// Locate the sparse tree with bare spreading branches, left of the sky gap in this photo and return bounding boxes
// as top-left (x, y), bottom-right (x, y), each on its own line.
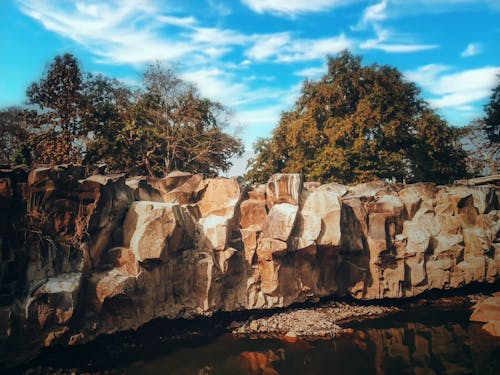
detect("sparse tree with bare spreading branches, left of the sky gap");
top-left (86, 64), bottom-right (243, 176)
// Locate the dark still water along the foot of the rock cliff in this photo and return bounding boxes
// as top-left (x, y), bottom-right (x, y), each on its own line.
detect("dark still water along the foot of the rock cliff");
top-left (11, 310), bottom-right (500, 375)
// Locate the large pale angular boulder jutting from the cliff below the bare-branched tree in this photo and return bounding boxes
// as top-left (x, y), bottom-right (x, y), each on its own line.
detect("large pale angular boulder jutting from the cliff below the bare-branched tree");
top-left (123, 202), bottom-right (189, 262)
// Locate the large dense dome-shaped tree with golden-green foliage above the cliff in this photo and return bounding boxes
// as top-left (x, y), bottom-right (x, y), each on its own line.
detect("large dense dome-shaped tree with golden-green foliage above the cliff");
top-left (246, 51), bottom-right (464, 183)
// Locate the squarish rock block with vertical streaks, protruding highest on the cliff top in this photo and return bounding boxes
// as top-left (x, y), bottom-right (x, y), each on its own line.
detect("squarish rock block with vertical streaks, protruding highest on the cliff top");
top-left (266, 173), bottom-right (302, 207)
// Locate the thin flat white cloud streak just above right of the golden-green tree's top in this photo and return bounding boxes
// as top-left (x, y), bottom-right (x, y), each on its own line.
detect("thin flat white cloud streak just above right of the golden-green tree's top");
top-left (360, 26), bottom-right (439, 53)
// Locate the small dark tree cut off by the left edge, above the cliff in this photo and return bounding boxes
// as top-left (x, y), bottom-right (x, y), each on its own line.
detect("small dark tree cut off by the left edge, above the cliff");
top-left (0, 107), bottom-right (29, 163)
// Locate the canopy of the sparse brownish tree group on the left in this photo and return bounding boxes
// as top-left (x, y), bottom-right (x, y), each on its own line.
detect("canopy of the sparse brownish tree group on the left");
top-left (0, 54), bottom-right (243, 176)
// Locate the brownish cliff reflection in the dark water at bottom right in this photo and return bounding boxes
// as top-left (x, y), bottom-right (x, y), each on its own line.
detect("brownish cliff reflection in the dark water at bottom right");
top-left (354, 323), bottom-right (500, 375)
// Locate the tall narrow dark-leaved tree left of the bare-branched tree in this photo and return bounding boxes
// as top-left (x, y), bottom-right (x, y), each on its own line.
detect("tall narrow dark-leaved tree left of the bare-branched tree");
top-left (26, 54), bottom-right (84, 165)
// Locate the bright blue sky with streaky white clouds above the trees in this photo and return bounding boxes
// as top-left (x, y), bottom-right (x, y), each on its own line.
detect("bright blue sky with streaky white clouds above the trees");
top-left (0, 0), bottom-right (500, 175)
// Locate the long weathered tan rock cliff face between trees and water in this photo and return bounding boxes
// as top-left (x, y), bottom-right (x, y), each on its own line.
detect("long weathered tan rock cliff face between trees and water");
top-left (0, 166), bottom-right (500, 358)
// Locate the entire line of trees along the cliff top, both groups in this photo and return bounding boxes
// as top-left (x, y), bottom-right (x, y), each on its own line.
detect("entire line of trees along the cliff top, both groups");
top-left (0, 51), bottom-right (500, 183)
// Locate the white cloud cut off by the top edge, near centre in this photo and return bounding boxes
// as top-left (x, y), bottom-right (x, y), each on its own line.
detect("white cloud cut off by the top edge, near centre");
top-left (243, 0), bottom-right (355, 15)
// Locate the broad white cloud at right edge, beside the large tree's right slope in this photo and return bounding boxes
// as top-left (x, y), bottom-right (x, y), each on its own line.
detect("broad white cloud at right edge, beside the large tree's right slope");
top-left (405, 64), bottom-right (500, 111)
